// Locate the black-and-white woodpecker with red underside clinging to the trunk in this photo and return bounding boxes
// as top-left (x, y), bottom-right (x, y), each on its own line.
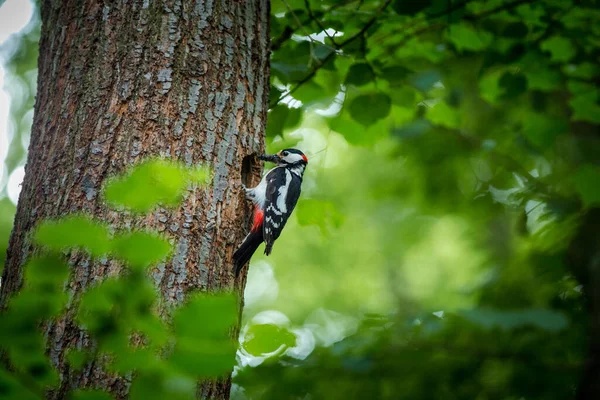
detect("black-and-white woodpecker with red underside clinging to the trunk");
top-left (233, 149), bottom-right (308, 275)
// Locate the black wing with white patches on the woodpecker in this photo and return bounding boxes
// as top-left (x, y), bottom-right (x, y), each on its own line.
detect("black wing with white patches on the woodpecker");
top-left (263, 168), bottom-right (302, 255)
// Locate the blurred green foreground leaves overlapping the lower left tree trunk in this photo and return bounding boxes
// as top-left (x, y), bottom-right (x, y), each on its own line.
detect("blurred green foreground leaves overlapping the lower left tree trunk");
top-left (0, 161), bottom-right (238, 399)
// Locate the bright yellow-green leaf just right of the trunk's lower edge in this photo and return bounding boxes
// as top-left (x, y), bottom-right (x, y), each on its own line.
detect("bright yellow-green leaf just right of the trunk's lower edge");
top-left (242, 324), bottom-right (296, 357)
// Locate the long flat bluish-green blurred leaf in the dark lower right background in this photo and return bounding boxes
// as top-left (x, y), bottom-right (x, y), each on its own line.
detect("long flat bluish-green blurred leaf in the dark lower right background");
top-left (460, 308), bottom-right (569, 332)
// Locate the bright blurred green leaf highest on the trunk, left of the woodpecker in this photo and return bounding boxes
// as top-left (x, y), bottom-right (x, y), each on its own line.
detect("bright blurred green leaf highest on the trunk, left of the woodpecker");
top-left (104, 160), bottom-right (188, 212)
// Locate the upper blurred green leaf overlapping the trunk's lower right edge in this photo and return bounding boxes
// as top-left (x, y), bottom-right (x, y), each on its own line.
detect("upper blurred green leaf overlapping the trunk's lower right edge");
top-left (173, 294), bottom-right (237, 339)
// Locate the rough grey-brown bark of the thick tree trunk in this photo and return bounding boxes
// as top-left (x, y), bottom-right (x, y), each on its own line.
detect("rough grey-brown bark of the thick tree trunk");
top-left (0, 0), bottom-right (269, 398)
